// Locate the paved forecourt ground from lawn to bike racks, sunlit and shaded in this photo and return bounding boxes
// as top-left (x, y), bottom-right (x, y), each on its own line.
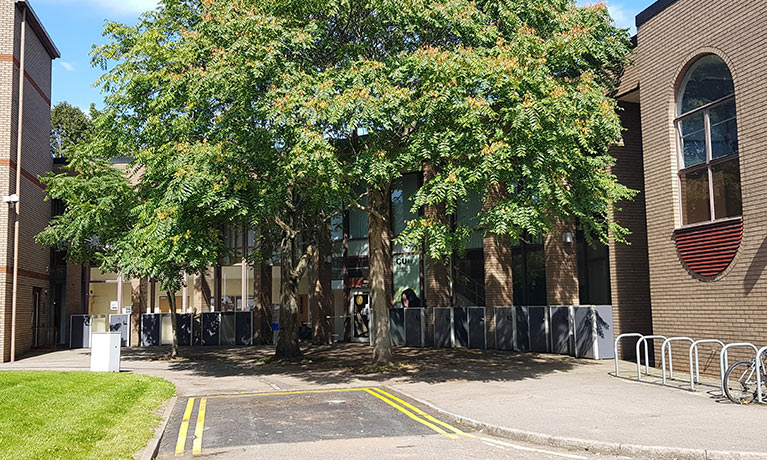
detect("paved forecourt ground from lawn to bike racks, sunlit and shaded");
top-left (0, 344), bottom-right (767, 459)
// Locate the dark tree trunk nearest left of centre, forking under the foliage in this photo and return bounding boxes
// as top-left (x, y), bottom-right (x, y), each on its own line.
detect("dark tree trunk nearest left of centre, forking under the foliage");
top-left (274, 236), bottom-right (301, 358)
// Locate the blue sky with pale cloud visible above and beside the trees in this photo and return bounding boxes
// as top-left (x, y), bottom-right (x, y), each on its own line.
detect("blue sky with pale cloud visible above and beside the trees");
top-left (30, 0), bottom-right (654, 110)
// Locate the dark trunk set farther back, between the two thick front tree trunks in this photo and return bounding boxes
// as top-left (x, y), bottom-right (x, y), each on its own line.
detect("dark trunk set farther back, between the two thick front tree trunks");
top-left (312, 221), bottom-right (333, 345)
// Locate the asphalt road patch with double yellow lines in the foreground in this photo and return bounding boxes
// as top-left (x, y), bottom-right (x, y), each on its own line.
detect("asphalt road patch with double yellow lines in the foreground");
top-left (158, 388), bottom-right (628, 460)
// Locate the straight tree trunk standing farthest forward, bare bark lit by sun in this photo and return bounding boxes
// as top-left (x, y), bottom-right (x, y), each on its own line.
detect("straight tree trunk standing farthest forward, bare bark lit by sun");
top-left (368, 187), bottom-right (393, 365)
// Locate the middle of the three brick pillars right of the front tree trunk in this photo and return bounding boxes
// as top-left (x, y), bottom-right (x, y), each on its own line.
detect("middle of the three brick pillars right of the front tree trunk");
top-left (483, 187), bottom-right (514, 348)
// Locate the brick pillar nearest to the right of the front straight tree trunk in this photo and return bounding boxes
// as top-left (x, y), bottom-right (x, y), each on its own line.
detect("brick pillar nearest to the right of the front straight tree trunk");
top-left (424, 162), bottom-right (452, 343)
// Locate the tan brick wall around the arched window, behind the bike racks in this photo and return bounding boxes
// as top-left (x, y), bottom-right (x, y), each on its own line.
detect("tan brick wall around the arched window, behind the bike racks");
top-left (637, 0), bottom-right (767, 372)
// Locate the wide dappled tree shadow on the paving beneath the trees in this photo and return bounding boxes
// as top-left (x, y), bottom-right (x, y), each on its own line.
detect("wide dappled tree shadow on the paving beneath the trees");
top-left (123, 344), bottom-right (595, 384)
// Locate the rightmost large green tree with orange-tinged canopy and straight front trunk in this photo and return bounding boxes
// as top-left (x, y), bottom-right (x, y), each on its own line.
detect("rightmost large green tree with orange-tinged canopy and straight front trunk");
top-left (219, 0), bottom-right (632, 363)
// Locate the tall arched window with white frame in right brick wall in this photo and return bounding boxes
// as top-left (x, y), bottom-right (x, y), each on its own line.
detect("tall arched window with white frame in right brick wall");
top-left (675, 54), bottom-right (742, 225)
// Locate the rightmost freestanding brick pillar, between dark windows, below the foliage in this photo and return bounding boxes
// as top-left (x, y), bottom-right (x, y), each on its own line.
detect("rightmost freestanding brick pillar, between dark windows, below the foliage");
top-left (543, 222), bottom-right (580, 305)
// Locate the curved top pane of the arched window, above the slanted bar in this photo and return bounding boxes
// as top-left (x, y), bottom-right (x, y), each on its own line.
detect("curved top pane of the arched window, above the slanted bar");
top-left (677, 54), bottom-right (735, 115)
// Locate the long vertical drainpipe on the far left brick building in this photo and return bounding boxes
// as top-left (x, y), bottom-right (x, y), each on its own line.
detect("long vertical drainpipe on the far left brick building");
top-left (11, 5), bottom-right (27, 362)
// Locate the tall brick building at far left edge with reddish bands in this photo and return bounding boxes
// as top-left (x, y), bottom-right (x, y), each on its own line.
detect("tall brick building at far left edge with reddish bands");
top-left (0, 0), bottom-right (57, 361)
